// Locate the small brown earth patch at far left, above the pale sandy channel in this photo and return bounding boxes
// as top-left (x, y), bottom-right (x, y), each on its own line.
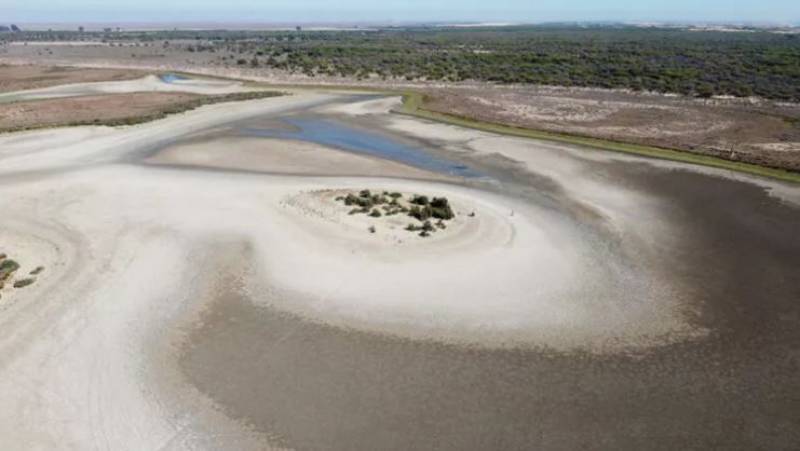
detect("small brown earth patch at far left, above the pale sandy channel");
top-left (0, 65), bottom-right (147, 92)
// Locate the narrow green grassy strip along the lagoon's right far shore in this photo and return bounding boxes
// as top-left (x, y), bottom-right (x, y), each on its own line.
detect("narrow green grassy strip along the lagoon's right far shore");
top-left (400, 92), bottom-right (800, 183)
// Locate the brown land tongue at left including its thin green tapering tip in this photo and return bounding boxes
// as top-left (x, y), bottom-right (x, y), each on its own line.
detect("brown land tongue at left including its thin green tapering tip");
top-left (0, 91), bottom-right (283, 132)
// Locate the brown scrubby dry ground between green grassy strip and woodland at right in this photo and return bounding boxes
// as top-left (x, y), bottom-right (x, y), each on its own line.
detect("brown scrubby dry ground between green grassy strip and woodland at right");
top-left (418, 87), bottom-right (800, 171)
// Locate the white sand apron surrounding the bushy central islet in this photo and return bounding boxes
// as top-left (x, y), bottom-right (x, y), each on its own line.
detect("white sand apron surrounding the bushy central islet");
top-left (261, 177), bottom-right (693, 349)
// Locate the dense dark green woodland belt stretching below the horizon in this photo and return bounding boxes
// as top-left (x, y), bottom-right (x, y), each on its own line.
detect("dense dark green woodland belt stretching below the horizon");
top-left (8, 25), bottom-right (800, 101)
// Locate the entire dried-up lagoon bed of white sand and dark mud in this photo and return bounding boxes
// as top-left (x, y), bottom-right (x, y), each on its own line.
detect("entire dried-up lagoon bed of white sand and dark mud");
top-left (0, 85), bottom-right (800, 449)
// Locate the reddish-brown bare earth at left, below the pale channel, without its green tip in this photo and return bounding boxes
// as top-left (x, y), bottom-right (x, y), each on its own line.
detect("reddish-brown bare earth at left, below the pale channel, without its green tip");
top-left (0, 92), bottom-right (203, 131)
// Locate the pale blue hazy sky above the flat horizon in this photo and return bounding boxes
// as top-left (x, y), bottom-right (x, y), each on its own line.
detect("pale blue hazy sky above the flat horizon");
top-left (6, 0), bottom-right (800, 23)
